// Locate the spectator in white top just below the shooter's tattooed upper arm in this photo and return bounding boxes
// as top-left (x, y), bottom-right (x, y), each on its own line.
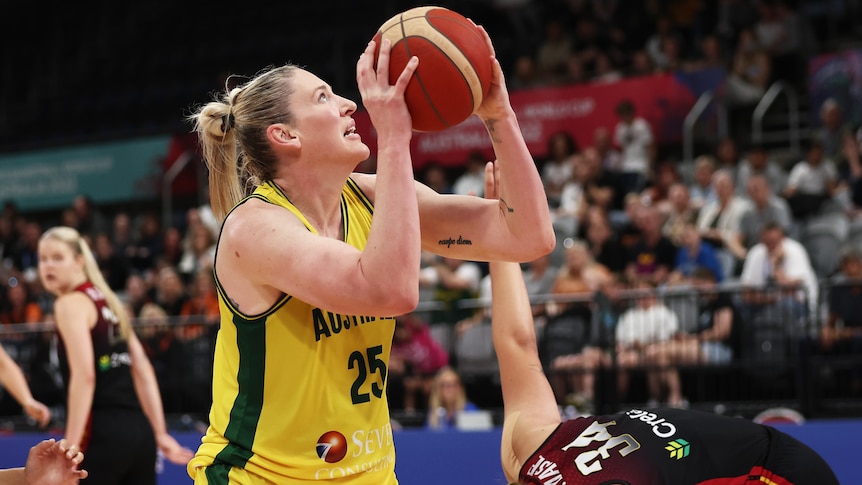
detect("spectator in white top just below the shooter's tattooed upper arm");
top-left (419, 256), bottom-right (482, 326)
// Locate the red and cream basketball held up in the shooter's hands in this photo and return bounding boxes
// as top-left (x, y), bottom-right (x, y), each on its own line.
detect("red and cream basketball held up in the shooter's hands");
top-left (374, 7), bottom-right (492, 131)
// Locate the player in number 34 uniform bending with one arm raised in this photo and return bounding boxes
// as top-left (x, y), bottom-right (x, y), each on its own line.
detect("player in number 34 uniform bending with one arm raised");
top-left (485, 170), bottom-right (838, 485)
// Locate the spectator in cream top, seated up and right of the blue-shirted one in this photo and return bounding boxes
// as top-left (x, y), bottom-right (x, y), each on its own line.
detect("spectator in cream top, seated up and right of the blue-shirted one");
top-left (697, 170), bottom-right (748, 277)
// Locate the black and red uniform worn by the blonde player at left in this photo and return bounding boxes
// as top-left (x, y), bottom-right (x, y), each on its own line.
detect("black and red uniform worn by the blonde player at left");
top-left (59, 282), bottom-right (156, 485)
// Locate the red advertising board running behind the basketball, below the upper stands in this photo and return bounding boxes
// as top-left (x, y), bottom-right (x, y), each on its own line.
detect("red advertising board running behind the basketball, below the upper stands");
top-left (354, 74), bottom-right (696, 168)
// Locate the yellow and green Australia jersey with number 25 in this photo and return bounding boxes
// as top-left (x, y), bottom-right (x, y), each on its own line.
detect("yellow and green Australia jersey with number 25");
top-left (188, 180), bottom-right (397, 485)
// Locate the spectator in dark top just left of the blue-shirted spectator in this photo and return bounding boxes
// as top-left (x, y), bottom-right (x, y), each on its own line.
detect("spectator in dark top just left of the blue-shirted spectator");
top-left (626, 203), bottom-right (677, 285)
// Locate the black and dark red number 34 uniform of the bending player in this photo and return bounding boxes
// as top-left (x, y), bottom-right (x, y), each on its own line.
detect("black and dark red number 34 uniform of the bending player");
top-left (520, 409), bottom-right (838, 485)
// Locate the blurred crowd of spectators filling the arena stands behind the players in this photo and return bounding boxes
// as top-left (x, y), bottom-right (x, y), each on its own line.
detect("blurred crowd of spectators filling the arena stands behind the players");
top-left (0, 0), bottom-right (862, 428)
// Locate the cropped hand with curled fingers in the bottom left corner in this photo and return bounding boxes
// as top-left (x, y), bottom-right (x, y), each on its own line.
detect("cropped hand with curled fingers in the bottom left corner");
top-left (24, 439), bottom-right (87, 485)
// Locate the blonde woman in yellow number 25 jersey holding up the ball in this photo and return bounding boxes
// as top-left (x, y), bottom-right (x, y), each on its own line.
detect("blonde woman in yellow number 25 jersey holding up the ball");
top-left (188, 30), bottom-right (554, 485)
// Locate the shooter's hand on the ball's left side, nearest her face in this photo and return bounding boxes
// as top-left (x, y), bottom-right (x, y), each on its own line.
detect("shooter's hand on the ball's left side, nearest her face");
top-left (356, 39), bottom-right (419, 140)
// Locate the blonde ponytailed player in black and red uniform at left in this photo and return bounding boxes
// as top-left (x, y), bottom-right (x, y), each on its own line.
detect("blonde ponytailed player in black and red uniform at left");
top-left (39, 226), bottom-right (192, 485)
